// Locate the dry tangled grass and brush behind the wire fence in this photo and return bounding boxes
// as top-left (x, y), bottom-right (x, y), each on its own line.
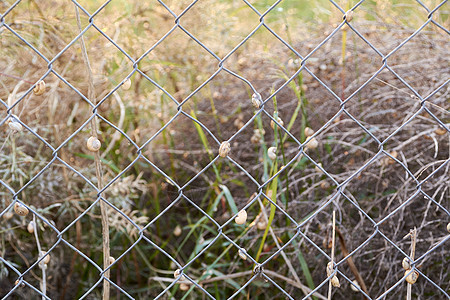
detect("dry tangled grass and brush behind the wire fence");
top-left (0, 1), bottom-right (450, 299)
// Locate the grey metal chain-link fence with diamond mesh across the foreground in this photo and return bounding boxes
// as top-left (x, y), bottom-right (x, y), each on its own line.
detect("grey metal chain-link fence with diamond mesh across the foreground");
top-left (0, 0), bottom-right (450, 299)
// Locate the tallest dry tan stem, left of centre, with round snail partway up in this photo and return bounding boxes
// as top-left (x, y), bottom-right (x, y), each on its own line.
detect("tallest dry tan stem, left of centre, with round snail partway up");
top-left (75, 6), bottom-right (110, 300)
